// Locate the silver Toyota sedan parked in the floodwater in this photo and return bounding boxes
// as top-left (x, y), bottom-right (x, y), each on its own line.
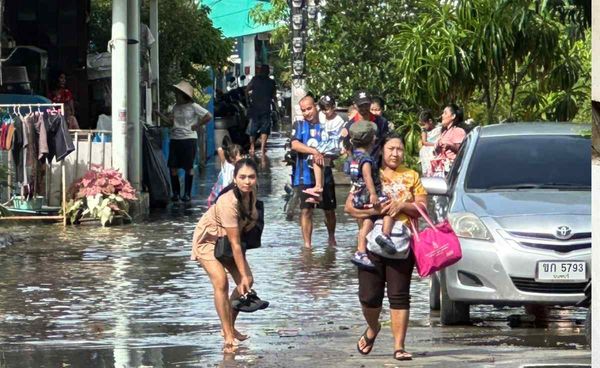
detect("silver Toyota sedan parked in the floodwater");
top-left (423, 123), bottom-right (592, 325)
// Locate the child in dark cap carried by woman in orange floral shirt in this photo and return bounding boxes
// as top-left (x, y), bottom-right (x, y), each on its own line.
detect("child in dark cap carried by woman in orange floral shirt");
top-left (346, 120), bottom-right (396, 269)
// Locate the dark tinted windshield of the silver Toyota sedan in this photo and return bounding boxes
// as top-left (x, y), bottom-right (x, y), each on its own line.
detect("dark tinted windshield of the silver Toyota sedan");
top-left (465, 135), bottom-right (592, 191)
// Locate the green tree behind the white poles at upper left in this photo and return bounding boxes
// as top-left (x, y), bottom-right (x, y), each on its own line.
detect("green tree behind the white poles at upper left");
top-left (90, 0), bottom-right (232, 108)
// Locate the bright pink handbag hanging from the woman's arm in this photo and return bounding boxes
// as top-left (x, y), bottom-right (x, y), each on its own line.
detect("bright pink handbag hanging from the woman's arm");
top-left (410, 203), bottom-right (462, 277)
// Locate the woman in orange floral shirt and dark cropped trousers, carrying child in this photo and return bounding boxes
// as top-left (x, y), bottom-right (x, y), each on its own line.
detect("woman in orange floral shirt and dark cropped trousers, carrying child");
top-left (345, 132), bottom-right (427, 360)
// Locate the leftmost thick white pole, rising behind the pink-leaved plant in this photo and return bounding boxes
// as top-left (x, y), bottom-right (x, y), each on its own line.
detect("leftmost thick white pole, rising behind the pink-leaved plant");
top-left (110, 0), bottom-right (128, 178)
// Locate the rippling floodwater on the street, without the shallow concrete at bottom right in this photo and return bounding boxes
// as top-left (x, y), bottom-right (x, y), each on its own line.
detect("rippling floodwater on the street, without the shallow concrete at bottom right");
top-left (0, 140), bottom-right (584, 367)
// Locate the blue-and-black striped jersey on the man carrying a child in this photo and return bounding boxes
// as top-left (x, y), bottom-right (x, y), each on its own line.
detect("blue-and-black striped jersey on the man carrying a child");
top-left (292, 120), bottom-right (322, 186)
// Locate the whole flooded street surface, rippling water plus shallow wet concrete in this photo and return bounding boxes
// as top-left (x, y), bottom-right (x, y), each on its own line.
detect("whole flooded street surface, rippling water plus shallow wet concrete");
top-left (0, 138), bottom-right (591, 368)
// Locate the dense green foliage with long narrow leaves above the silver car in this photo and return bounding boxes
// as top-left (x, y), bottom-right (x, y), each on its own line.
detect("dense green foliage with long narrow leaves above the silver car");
top-left (255, 0), bottom-right (591, 124)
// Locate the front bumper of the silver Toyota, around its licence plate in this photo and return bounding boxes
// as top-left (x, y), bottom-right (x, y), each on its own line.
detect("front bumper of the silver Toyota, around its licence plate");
top-left (442, 235), bottom-right (591, 305)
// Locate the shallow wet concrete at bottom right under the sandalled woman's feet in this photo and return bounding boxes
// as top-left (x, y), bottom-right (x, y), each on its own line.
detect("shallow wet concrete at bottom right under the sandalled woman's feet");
top-left (219, 326), bottom-right (591, 368)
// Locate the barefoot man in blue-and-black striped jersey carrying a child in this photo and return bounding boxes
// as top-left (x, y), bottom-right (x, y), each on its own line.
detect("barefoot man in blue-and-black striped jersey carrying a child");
top-left (292, 96), bottom-right (337, 248)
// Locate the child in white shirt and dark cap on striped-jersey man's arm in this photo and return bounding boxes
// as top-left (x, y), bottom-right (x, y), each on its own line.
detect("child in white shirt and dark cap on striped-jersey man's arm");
top-left (304, 95), bottom-right (346, 203)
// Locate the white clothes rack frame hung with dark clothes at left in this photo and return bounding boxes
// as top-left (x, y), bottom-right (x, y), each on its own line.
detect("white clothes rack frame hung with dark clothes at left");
top-left (0, 103), bottom-right (67, 226)
